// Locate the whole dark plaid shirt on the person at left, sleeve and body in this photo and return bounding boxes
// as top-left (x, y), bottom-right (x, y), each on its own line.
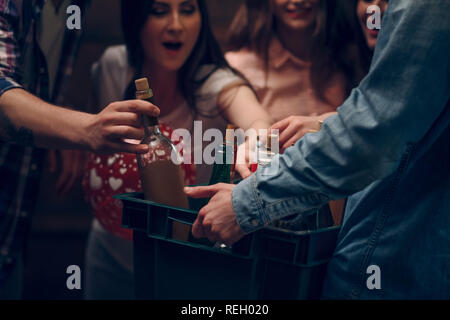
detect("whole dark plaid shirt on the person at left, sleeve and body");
top-left (0, 0), bottom-right (87, 285)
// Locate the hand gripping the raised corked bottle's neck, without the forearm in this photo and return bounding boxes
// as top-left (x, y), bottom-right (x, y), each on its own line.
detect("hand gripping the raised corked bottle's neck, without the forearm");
top-left (86, 100), bottom-right (159, 153)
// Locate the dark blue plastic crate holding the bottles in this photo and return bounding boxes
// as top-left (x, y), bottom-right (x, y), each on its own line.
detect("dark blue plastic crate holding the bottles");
top-left (115, 193), bottom-right (339, 300)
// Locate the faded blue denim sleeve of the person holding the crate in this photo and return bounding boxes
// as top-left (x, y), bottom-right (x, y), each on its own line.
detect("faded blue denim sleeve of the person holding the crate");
top-left (232, 0), bottom-right (450, 233)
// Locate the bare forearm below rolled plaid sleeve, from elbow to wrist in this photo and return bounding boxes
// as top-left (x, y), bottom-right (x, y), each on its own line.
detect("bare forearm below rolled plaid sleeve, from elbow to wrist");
top-left (0, 89), bottom-right (92, 148)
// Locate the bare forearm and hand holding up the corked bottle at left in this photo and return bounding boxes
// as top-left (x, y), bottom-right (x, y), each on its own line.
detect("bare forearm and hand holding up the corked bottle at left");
top-left (0, 88), bottom-right (159, 153)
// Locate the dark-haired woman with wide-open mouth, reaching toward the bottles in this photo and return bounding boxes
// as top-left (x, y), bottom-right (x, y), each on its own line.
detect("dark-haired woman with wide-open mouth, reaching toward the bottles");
top-left (83, 0), bottom-right (272, 299)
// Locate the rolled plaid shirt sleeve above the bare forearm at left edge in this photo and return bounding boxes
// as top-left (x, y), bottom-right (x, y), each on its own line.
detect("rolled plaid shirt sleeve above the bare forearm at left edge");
top-left (0, 0), bottom-right (22, 95)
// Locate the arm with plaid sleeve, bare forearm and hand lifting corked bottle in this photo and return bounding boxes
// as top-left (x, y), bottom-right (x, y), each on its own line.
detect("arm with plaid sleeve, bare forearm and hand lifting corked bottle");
top-left (0, 1), bottom-right (159, 153)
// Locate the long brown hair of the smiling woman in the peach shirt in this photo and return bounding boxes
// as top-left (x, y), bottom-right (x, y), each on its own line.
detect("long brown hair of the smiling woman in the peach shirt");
top-left (227, 0), bottom-right (358, 101)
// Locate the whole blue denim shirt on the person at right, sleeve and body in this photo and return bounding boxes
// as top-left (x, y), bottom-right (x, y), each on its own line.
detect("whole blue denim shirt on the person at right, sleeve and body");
top-left (233, 0), bottom-right (450, 299)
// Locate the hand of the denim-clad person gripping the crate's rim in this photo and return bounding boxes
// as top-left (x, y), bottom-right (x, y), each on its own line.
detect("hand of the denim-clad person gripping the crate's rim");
top-left (184, 183), bottom-right (245, 246)
